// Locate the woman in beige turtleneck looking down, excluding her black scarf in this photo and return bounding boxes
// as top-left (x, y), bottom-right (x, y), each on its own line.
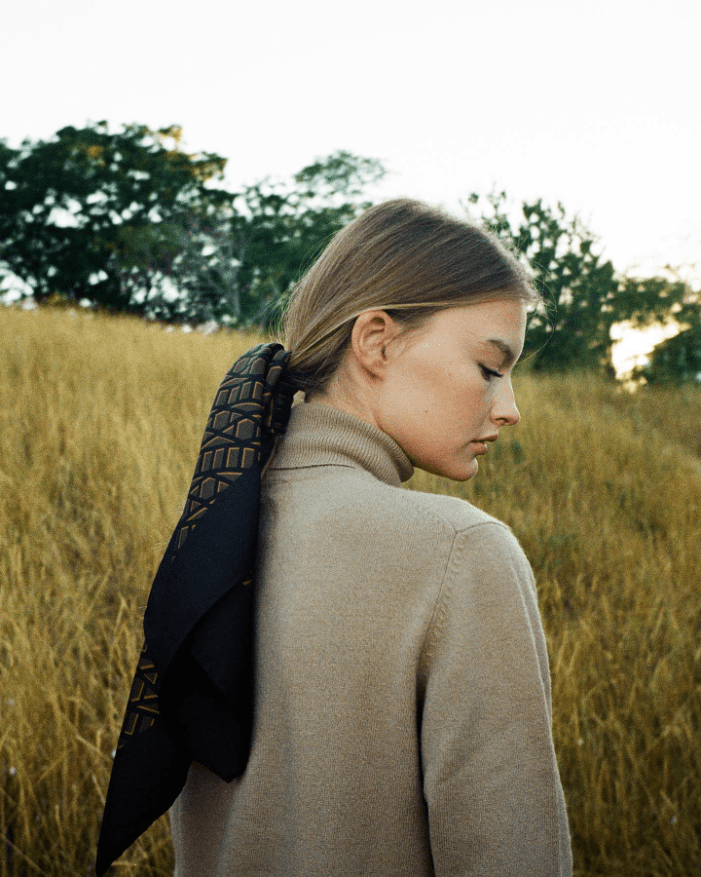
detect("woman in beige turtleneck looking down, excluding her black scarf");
top-left (97, 200), bottom-right (572, 877)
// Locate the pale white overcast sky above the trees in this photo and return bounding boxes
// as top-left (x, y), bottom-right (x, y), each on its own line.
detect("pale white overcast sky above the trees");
top-left (0, 0), bottom-right (701, 282)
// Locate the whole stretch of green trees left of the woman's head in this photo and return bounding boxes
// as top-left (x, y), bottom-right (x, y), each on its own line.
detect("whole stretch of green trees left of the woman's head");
top-left (0, 122), bottom-right (385, 326)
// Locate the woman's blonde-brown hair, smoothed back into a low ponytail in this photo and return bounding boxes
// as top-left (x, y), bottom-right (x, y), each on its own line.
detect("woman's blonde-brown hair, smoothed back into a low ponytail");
top-left (282, 199), bottom-right (540, 393)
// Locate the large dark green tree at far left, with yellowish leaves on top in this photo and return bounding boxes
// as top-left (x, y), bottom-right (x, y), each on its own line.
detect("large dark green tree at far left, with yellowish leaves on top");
top-left (0, 122), bottom-right (234, 314)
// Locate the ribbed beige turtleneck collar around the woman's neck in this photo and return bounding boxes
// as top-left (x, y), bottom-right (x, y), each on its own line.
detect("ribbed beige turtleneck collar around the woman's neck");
top-left (266, 402), bottom-right (414, 487)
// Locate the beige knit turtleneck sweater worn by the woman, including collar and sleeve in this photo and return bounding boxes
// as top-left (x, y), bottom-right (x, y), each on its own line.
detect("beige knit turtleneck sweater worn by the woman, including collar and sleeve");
top-left (171, 403), bottom-right (572, 877)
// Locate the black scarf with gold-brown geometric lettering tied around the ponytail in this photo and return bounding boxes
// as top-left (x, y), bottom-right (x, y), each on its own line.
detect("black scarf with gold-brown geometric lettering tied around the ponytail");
top-left (95, 344), bottom-right (295, 877)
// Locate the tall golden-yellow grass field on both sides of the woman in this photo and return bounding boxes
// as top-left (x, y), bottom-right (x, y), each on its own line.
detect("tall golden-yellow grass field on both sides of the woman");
top-left (0, 308), bottom-right (701, 877)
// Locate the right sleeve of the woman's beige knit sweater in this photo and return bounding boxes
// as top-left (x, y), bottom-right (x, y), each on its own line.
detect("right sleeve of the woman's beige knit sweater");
top-left (421, 522), bottom-right (572, 877)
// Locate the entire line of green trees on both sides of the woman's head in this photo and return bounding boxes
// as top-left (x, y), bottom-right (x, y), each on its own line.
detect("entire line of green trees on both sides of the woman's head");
top-left (0, 122), bottom-right (701, 381)
